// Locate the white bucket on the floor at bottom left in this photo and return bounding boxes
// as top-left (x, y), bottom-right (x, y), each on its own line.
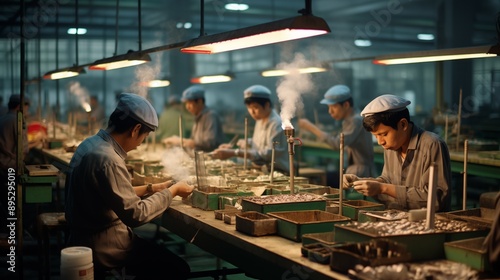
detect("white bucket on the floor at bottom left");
top-left (61, 247), bottom-right (94, 280)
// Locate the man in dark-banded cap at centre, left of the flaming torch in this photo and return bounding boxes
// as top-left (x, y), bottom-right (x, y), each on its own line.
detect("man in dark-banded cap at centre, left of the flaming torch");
top-left (214, 85), bottom-right (290, 175)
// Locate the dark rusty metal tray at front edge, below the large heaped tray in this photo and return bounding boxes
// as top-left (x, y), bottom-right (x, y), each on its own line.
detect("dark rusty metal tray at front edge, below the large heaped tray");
top-left (330, 239), bottom-right (411, 273)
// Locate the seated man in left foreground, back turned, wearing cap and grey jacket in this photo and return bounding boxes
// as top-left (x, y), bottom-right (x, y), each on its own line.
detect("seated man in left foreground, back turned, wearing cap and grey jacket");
top-left (65, 93), bottom-right (193, 279)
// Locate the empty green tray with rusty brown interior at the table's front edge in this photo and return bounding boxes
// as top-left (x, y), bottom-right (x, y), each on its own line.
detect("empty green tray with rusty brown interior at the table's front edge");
top-left (268, 210), bottom-right (350, 242)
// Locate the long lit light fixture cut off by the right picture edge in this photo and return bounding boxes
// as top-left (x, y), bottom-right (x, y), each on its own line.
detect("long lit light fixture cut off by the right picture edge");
top-left (373, 45), bottom-right (500, 65)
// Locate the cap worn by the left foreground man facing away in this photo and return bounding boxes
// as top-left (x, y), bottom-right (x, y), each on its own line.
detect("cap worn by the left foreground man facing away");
top-left (115, 93), bottom-right (158, 130)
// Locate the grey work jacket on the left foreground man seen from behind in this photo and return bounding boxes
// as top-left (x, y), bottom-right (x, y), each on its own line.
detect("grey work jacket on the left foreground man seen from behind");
top-left (65, 130), bottom-right (172, 268)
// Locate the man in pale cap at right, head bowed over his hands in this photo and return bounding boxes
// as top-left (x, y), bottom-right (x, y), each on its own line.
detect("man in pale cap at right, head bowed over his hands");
top-left (343, 94), bottom-right (451, 212)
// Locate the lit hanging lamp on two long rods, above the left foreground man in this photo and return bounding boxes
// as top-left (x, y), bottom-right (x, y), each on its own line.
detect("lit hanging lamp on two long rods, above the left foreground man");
top-left (89, 0), bottom-right (151, 70)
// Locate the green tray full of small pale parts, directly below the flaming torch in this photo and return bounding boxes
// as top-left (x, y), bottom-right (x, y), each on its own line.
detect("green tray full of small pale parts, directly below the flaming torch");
top-left (241, 193), bottom-right (326, 214)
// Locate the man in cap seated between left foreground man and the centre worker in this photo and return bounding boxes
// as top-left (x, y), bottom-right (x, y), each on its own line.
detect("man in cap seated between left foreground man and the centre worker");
top-left (163, 85), bottom-right (225, 152)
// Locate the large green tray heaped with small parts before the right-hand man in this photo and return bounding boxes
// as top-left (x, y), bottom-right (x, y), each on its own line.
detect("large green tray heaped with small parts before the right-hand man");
top-left (335, 219), bottom-right (488, 261)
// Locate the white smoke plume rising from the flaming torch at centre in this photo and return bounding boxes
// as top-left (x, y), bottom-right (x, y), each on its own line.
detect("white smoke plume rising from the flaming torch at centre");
top-left (276, 53), bottom-right (314, 129)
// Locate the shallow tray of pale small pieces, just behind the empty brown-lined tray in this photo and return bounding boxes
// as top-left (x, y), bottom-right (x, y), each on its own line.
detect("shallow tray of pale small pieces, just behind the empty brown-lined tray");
top-left (241, 193), bottom-right (326, 214)
